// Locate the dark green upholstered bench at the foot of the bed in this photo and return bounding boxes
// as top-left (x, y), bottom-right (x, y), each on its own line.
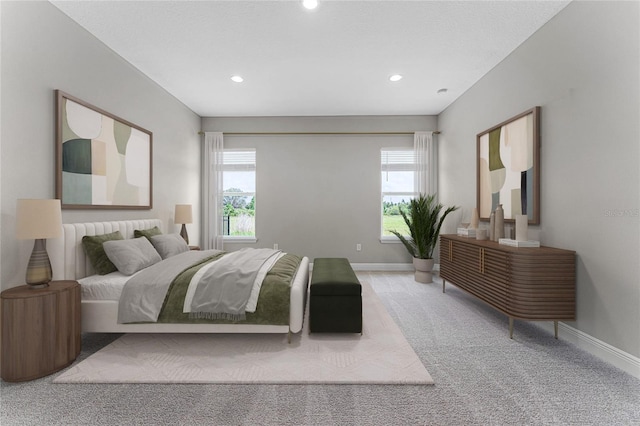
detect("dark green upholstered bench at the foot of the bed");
top-left (309, 258), bottom-right (362, 333)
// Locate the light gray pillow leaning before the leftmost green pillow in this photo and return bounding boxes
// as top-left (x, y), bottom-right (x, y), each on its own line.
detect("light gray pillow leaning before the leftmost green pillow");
top-left (102, 237), bottom-right (162, 275)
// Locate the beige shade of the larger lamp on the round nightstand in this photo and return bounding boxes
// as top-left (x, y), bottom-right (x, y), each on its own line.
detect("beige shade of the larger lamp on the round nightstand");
top-left (16, 199), bottom-right (62, 240)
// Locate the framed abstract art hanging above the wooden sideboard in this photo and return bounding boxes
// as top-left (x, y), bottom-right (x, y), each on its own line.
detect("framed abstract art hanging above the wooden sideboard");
top-left (476, 107), bottom-right (540, 225)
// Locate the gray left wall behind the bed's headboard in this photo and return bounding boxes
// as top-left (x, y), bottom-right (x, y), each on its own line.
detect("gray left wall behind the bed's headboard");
top-left (0, 2), bottom-right (200, 289)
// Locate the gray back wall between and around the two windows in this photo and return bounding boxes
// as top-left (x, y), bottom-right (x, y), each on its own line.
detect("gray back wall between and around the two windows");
top-left (203, 116), bottom-right (437, 264)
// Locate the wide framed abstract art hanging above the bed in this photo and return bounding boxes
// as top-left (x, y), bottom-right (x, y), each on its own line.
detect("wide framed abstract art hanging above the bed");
top-left (56, 90), bottom-right (153, 210)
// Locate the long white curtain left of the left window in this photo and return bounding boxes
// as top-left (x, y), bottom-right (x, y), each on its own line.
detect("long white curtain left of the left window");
top-left (202, 132), bottom-right (224, 250)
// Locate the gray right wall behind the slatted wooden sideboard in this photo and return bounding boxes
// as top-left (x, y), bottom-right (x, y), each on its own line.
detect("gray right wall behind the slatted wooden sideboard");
top-left (438, 2), bottom-right (640, 357)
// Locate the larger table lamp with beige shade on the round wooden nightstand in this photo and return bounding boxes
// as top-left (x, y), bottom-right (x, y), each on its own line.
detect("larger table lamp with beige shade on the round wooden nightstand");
top-left (16, 199), bottom-right (62, 288)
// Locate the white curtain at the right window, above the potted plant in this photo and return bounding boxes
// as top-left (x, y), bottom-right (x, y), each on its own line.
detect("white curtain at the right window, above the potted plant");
top-left (413, 132), bottom-right (438, 200)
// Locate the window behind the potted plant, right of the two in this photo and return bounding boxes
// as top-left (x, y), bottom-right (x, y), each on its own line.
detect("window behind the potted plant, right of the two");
top-left (380, 148), bottom-right (416, 240)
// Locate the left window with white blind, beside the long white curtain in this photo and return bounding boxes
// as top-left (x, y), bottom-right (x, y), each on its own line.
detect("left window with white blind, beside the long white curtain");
top-left (222, 149), bottom-right (256, 239)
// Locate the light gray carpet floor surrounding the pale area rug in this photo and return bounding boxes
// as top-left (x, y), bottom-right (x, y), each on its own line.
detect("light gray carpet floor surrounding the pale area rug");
top-left (0, 271), bottom-right (640, 426)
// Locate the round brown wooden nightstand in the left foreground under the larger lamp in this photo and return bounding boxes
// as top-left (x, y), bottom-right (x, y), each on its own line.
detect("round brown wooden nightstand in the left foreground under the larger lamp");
top-left (0, 281), bottom-right (81, 382)
